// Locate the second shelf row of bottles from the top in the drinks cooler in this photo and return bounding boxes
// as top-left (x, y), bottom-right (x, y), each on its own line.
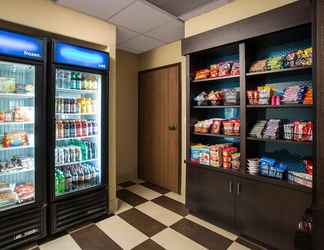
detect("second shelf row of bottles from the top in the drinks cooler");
top-left (55, 97), bottom-right (96, 114)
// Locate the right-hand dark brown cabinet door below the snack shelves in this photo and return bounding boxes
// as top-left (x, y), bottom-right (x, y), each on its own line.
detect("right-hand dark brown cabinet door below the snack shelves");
top-left (236, 178), bottom-right (311, 250)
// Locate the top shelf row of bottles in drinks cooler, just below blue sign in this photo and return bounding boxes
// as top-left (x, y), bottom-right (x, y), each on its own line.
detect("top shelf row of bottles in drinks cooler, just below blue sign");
top-left (56, 70), bottom-right (98, 90)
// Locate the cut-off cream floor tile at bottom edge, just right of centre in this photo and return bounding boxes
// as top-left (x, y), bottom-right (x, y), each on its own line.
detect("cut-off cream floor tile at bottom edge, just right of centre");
top-left (151, 228), bottom-right (206, 250)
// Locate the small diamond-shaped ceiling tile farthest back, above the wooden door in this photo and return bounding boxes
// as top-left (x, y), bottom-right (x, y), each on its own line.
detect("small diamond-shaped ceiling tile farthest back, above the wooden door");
top-left (120, 35), bottom-right (163, 53)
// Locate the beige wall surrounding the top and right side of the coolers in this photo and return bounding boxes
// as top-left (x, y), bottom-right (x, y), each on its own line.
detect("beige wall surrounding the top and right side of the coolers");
top-left (0, 0), bottom-right (116, 210)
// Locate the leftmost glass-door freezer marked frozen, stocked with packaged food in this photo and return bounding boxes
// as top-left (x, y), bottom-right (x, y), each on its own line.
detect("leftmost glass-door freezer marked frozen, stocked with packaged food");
top-left (0, 29), bottom-right (47, 249)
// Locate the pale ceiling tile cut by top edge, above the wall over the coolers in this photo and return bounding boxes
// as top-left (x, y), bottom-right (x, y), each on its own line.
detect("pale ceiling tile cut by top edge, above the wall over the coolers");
top-left (57, 0), bottom-right (134, 20)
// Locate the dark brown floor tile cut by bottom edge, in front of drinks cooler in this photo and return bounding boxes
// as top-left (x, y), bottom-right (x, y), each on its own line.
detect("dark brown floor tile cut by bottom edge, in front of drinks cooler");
top-left (71, 225), bottom-right (122, 250)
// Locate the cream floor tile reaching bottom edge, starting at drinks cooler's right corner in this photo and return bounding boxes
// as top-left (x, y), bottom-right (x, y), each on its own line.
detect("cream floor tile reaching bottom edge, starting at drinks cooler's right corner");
top-left (97, 216), bottom-right (148, 250)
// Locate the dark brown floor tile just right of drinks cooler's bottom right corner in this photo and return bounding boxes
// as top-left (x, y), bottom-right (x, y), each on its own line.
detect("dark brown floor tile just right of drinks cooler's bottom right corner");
top-left (118, 208), bottom-right (166, 237)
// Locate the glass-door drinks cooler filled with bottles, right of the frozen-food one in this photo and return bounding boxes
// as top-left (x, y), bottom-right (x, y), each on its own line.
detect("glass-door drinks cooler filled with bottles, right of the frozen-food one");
top-left (49, 41), bottom-right (109, 233)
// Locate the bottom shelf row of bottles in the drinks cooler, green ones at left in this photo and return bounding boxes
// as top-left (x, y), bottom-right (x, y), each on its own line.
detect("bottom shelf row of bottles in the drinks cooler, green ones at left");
top-left (55, 163), bottom-right (100, 195)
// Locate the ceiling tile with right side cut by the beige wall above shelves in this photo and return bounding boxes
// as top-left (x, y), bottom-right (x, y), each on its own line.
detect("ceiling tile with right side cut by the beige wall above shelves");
top-left (145, 20), bottom-right (184, 43)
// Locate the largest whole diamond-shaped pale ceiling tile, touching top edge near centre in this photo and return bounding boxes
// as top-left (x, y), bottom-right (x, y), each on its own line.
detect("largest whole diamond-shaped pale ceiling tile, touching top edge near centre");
top-left (109, 1), bottom-right (175, 33)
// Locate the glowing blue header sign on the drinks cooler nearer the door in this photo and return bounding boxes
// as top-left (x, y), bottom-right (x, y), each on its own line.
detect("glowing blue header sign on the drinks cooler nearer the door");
top-left (54, 42), bottom-right (109, 70)
